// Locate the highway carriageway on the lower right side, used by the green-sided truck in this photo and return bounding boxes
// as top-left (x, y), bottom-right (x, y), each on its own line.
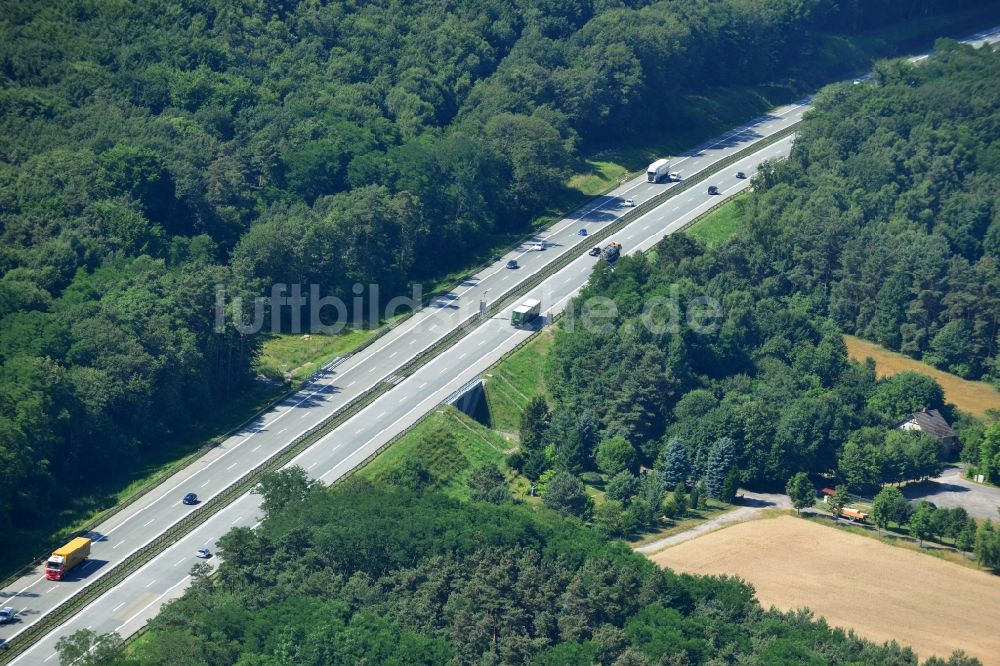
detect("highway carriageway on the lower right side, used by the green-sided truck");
top-left (5, 131), bottom-right (791, 663)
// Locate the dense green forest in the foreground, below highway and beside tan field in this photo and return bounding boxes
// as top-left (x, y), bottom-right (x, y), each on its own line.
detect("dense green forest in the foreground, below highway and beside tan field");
top-left (60, 470), bottom-right (978, 666)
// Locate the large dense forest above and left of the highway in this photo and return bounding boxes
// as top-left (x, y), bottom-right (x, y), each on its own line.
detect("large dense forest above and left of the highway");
top-left (0, 0), bottom-right (980, 534)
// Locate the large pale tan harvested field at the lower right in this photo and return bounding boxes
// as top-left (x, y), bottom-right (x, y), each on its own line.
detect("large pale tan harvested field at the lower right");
top-left (651, 516), bottom-right (1000, 664)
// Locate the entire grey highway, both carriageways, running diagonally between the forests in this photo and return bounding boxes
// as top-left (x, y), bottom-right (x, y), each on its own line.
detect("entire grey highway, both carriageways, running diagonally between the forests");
top-left (0, 26), bottom-right (996, 663)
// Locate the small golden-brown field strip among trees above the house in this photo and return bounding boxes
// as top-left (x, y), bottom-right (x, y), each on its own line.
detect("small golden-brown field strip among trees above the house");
top-left (844, 335), bottom-right (1000, 417)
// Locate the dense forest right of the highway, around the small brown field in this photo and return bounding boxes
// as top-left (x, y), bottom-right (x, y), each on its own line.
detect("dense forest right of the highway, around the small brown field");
top-left (511, 43), bottom-right (1000, 500)
